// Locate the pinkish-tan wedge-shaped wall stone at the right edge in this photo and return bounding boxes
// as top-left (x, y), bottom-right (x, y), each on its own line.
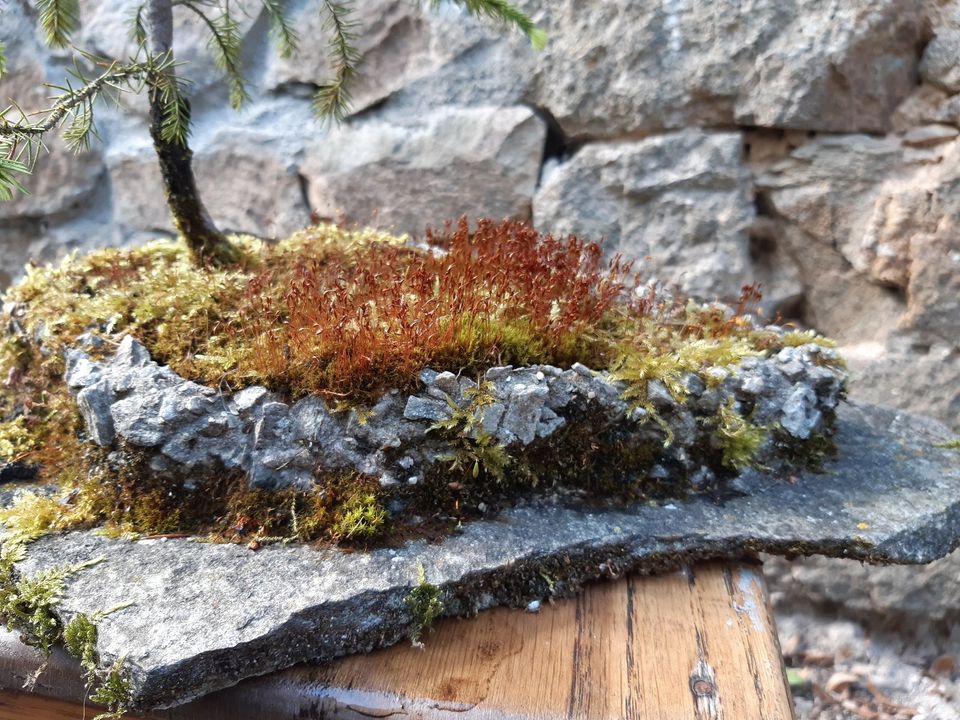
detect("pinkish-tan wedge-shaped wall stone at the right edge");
top-left (756, 132), bottom-right (960, 318)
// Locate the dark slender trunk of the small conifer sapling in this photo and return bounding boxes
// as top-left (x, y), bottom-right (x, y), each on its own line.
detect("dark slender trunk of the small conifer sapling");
top-left (146, 0), bottom-right (236, 264)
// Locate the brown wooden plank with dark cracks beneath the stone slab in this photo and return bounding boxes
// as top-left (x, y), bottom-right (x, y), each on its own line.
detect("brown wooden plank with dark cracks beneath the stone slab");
top-left (0, 564), bottom-right (794, 720)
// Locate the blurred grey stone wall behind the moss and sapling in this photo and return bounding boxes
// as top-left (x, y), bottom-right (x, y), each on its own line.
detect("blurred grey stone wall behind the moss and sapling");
top-left (0, 0), bottom-right (960, 427)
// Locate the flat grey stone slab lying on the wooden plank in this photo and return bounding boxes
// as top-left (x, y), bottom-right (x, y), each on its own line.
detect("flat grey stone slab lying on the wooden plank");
top-left (9, 406), bottom-right (960, 706)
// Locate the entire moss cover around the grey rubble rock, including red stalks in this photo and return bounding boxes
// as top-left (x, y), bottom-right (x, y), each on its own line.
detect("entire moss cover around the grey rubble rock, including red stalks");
top-left (0, 221), bottom-right (841, 546)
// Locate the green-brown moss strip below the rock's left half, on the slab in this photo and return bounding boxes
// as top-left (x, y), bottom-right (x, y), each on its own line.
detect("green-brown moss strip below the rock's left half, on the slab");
top-left (0, 447), bottom-right (389, 547)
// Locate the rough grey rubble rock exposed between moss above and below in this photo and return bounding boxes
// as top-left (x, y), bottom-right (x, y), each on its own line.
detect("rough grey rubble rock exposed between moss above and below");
top-left (65, 336), bottom-right (845, 496)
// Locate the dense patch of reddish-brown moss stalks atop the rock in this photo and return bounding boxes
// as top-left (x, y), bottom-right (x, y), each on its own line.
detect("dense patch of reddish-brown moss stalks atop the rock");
top-left (244, 221), bottom-right (636, 397)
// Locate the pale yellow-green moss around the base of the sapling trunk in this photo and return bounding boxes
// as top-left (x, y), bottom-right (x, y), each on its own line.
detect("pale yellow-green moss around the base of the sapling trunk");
top-left (0, 225), bottom-right (405, 394)
